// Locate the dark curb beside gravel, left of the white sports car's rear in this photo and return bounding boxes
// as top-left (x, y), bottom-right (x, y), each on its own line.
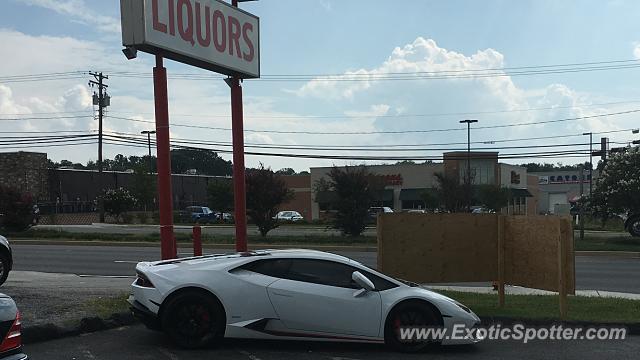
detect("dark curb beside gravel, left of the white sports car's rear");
top-left (22, 312), bottom-right (137, 344)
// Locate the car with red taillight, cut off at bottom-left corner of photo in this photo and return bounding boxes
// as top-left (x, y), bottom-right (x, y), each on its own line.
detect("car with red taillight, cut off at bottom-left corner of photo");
top-left (0, 294), bottom-right (28, 360)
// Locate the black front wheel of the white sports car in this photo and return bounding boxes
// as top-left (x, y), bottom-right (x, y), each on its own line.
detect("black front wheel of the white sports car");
top-left (384, 301), bottom-right (442, 352)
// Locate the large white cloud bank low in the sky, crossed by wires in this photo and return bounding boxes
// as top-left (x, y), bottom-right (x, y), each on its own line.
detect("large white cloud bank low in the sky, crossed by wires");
top-left (0, 29), bottom-right (633, 170)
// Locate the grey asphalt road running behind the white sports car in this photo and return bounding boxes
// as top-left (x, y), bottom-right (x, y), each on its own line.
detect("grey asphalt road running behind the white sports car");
top-left (12, 244), bottom-right (640, 294)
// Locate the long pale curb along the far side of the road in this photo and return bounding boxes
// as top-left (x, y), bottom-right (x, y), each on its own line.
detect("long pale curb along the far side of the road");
top-left (11, 239), bottom-right (378, 252)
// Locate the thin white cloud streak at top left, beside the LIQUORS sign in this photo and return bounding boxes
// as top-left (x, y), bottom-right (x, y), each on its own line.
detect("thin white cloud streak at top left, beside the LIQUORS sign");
top-left (19, 0), bottom-right (120, 34)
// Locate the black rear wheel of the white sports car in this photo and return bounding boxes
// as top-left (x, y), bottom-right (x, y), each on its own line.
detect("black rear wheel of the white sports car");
top-left (162, 291), bottom-right (226, 349)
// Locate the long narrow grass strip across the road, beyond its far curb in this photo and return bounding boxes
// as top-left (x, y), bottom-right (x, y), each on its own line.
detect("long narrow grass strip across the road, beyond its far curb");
top-left (6, 229), bottom-right (377, 245)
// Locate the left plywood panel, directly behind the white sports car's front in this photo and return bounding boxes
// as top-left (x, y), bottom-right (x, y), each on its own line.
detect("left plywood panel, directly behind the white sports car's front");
top-left (378, 214), bottom-right (498, 283)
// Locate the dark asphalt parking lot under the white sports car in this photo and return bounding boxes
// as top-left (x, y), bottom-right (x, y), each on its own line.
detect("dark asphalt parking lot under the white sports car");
top-left (25, 326), bottom-right (640, 360)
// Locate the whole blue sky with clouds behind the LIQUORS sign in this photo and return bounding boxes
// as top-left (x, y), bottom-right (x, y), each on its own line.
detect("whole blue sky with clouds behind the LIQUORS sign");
top-left (0, 0), bottom-right (640, 170)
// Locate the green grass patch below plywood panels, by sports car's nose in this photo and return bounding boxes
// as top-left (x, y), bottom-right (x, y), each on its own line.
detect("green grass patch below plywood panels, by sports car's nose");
top-left (438, 291), bottom-right (640, 324)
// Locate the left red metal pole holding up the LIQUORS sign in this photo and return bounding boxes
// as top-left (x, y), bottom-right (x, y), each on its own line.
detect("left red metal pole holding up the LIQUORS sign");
top-left (153, 55), bottom-right (177, 260)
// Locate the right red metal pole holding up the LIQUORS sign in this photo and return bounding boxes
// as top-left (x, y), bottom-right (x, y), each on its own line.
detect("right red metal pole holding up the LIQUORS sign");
top-left (228, 0), bottom-right (247, 252)
